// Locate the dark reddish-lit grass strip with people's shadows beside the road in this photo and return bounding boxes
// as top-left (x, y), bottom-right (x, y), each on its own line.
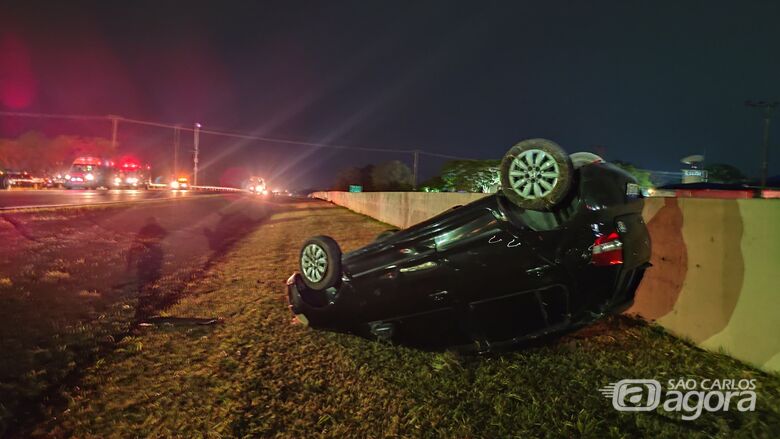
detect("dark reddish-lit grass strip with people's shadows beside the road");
top-left (0, 196), bottom-right (268, 437)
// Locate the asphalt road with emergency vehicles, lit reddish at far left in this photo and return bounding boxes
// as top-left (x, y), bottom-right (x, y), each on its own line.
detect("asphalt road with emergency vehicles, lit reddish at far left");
top-left (0, 189), bottom-right (207, 209)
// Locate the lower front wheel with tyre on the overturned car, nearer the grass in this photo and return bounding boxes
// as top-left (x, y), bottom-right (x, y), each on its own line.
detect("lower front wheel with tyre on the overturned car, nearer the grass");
top-left (300, 236), bottom-right (341, 290)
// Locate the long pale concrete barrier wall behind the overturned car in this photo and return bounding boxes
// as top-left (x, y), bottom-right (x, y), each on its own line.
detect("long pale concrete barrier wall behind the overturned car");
top-left (315, 192), bottom-right (780, 372)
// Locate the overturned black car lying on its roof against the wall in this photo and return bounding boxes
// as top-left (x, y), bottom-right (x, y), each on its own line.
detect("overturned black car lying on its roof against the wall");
top-left (287, 139), bottom-right (650, 352)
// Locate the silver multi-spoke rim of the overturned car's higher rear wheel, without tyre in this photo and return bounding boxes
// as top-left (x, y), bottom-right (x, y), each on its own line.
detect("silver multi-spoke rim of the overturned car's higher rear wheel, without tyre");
top-left (509, 149), bottom-right (561, 200)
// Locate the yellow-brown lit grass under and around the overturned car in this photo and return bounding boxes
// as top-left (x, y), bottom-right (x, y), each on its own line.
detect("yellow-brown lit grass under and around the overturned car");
top-left (24, 203), bottom-right (780, 438)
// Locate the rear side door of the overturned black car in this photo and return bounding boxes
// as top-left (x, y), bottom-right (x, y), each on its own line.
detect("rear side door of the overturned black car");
top-left (437, 203), bottom-right (568, 341)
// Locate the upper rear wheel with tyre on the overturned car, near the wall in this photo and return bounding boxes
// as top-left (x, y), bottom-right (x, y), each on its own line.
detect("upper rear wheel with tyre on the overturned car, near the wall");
top-left (501, 139), bottom-right (573, 211)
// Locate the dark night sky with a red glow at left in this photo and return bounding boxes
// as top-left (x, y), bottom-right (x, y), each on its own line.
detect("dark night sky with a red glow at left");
top-left (0, 0), bottom-right (780, 187)
